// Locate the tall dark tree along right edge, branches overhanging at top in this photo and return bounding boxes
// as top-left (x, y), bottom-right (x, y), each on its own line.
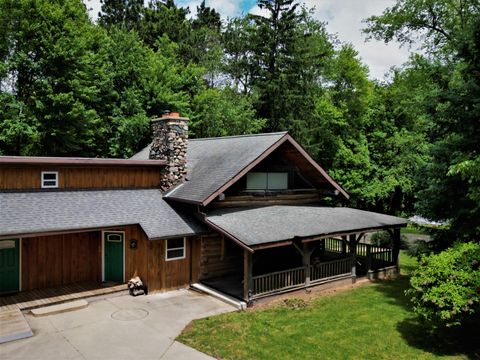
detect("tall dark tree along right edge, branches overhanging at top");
top-left (367, 0), bottom-right (480, 239)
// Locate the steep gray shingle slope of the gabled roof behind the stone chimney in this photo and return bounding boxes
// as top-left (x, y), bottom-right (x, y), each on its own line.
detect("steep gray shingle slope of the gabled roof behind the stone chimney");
top-left (131, 132), bottom-right (286, 203)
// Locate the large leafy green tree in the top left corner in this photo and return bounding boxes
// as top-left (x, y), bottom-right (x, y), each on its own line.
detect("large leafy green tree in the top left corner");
top-left (0, 0), bottom-right (108, 156)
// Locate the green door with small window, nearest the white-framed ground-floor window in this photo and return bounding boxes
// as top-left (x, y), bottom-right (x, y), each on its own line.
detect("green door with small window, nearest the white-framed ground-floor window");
top-left (103, 232), bottom-right (123, 282)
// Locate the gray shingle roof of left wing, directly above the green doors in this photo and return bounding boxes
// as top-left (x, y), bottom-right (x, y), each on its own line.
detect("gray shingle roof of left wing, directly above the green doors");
top-left (0, 190), bottom-right (205, 239)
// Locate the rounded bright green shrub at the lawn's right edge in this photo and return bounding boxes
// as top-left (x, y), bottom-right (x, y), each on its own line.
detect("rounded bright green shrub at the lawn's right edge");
top-left (406, 243), bottom-right (480, 327)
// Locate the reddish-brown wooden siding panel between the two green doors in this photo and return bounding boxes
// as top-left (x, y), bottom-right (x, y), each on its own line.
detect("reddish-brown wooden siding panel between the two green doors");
top-left (21, 232), bottom-right (101, 290)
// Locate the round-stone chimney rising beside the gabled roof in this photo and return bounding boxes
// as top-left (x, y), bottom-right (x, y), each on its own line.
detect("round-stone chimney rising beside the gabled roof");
top-left (149, 113), bottom-right (188, 191)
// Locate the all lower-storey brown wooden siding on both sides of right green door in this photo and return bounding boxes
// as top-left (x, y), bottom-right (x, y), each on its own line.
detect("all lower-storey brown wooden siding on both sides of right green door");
top-left (22, 226), bottom-right (200, 292)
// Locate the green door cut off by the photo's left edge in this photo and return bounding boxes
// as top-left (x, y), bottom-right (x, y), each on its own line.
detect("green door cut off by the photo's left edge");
top-left (0, 239), bottom-right (20, 293)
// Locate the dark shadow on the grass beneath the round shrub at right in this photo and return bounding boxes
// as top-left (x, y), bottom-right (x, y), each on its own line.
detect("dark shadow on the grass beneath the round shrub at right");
top-left (376, 276), bottom-right (480, 359)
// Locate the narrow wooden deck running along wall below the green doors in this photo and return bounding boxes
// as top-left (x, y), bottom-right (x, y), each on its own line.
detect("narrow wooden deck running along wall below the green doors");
top-left (0, 282), bottom-right (127, 312)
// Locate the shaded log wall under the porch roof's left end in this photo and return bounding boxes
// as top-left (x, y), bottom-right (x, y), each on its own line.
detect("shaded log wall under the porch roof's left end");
top-left (199, 234), bottom-right (243, 280)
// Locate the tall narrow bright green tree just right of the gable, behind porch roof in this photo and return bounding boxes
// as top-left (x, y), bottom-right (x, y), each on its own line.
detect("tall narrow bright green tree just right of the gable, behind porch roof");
top-left (318, 45), bottom-right (372, 206)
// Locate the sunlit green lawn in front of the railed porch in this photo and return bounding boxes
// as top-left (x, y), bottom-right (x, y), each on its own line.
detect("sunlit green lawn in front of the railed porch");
top-left (177, 254), bottom-right (480, 360)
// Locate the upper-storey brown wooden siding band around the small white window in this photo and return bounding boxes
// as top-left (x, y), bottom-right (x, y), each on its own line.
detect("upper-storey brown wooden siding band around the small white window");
top-left (0, 166), bottom-right (161, 190)
